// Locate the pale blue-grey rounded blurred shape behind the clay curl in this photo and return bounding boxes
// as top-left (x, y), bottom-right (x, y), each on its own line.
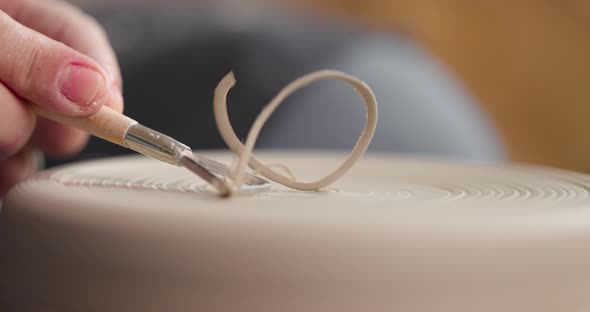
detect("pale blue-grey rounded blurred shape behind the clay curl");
top-left (264, 34), bottom-right (504, 161)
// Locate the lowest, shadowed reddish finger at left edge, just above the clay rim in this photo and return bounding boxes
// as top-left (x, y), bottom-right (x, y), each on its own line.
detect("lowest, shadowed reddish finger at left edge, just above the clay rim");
top-left (0, 151), bottom-right (36, 198)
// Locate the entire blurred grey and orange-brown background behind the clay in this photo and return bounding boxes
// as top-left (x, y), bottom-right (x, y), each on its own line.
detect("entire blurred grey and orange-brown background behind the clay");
top-left (50, 0), bottom-right (590, 171)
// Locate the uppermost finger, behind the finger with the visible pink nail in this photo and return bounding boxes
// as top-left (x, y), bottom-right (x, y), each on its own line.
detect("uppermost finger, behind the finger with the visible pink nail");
top-left (2, 0), bottom-right (123, 110)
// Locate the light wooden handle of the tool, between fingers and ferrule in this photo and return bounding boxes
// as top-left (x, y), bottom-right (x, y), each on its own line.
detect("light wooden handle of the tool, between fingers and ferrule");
top-left (31, 105), bottom-right (137, 147)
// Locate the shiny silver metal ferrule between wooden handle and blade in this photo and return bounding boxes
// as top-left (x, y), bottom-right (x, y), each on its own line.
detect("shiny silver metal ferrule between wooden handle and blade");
top-left (125, 124), bottom-right (191, 166)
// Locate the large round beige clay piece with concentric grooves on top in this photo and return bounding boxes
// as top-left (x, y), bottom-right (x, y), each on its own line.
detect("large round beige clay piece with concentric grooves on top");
top-left (0, 153), bottom-right (590, 312)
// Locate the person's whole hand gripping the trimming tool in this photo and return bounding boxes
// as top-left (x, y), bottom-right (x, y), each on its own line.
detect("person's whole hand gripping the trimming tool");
top-left (0, 0), bottom-right (123, 198)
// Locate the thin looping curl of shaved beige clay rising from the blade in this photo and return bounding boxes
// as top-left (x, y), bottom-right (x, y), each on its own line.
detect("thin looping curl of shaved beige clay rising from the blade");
top-left (213, 70), bottom-right (377, 191)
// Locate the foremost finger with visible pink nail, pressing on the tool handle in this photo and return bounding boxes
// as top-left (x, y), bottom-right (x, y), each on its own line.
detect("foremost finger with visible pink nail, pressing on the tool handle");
top-left (0, 11), bottom-right (111, 115)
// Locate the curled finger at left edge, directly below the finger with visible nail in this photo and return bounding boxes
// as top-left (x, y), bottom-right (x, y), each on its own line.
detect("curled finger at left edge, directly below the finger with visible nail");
top-left (0, 83), bottom-right (35, 160)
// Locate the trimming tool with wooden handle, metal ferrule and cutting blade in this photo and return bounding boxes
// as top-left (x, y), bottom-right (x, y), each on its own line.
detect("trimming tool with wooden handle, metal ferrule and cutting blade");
top-left (31, 105), bottom-right (270, 196)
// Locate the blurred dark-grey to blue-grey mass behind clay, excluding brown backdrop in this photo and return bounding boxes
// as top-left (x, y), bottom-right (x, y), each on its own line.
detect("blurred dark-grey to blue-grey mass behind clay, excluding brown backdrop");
top-left (49, 7), bottom-right (503, 166)
